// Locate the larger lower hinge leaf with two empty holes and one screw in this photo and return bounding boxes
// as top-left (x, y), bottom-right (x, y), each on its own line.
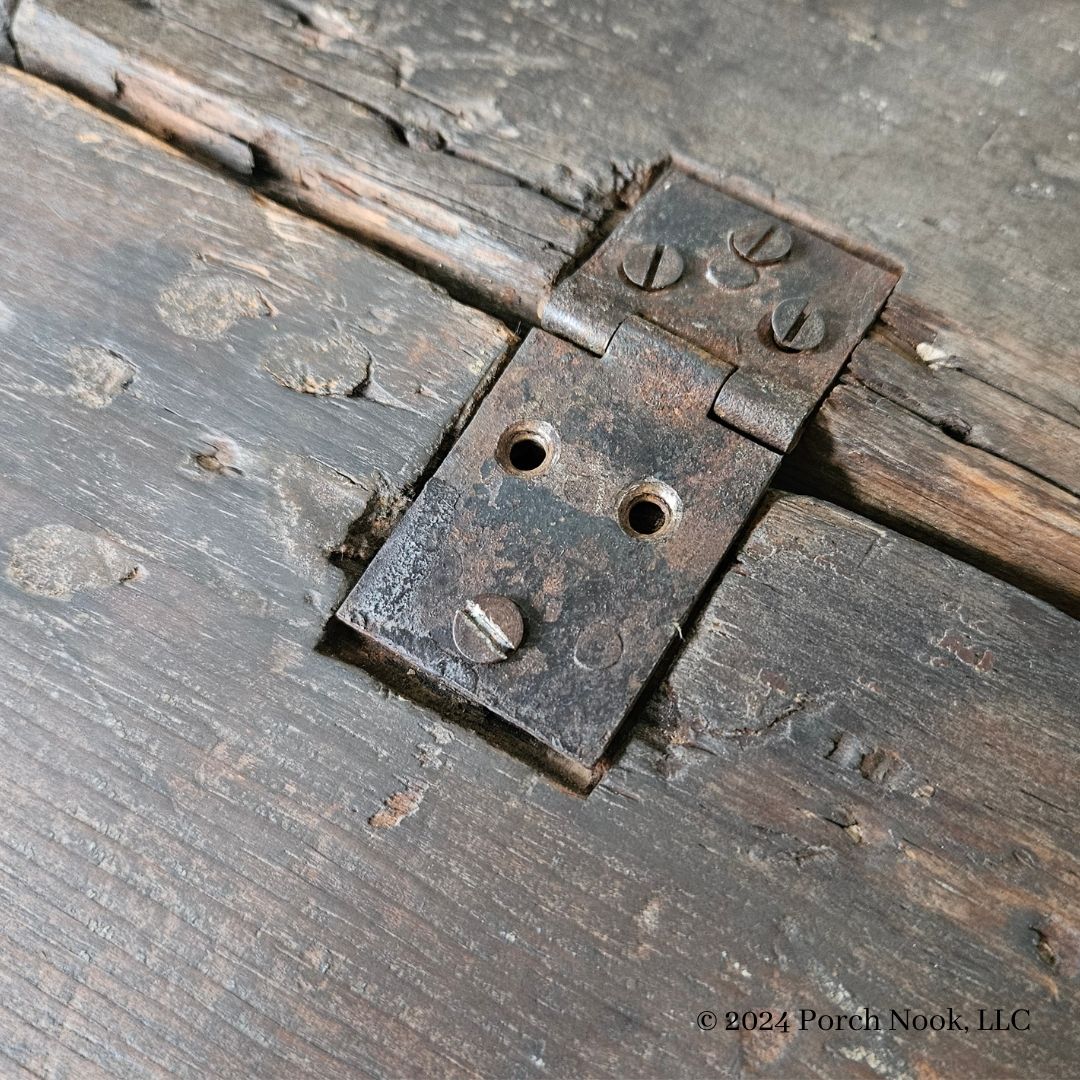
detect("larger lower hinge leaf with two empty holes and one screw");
top-left (338, 319), bottom-right (780, 765)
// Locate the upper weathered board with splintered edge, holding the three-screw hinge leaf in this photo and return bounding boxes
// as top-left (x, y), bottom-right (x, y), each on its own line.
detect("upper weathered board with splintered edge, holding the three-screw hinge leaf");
top-left (14, 0), bottom-right (1080, 626)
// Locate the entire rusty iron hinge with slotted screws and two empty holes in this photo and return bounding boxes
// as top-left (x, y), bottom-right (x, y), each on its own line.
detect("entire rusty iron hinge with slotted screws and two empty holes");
top-left (338, 170), bottom-right (896, 766)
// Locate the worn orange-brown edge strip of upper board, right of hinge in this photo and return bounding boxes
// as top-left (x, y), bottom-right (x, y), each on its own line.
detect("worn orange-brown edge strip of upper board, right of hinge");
top-left (779, 341), bottom-right (1080, 616)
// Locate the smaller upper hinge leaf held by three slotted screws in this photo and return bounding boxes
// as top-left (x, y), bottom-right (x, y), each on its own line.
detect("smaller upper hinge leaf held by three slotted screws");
top-left (542, 170), bottom-right (897, 451)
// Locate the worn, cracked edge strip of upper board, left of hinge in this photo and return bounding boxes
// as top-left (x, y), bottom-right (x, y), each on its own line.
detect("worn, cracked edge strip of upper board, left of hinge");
top-left (8, 0), bottom-right (589, 319)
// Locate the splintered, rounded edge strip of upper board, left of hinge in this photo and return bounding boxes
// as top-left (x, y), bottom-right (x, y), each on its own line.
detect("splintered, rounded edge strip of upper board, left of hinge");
top-left (12, 0), bottom-right (592, 322)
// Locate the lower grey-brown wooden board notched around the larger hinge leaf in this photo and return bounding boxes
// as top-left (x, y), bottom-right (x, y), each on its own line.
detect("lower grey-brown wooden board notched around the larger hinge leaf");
top-left (0, 65), bottom-right (1080, 1080)
